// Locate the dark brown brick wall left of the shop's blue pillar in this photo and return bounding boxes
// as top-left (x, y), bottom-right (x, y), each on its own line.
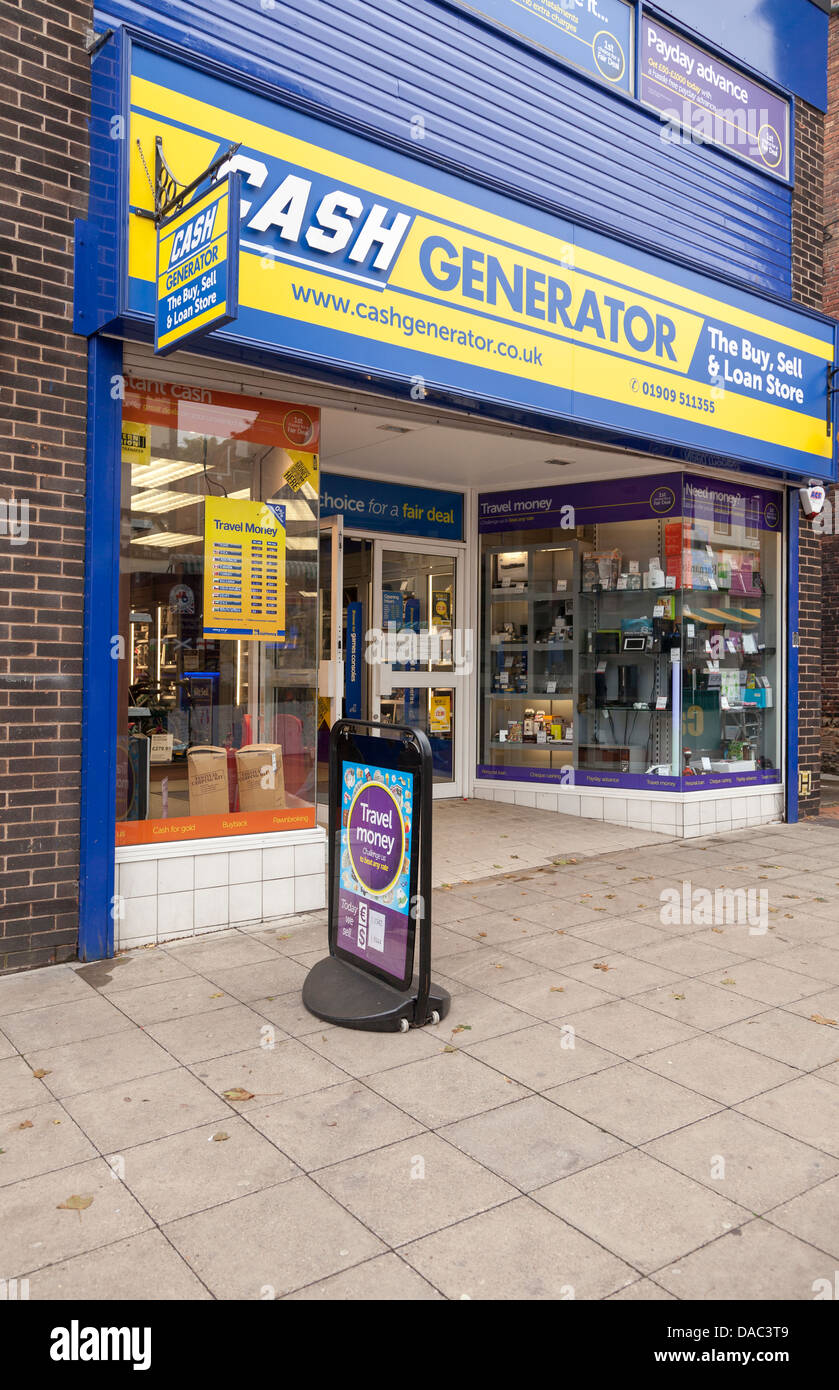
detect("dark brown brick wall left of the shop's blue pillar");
top-left (0, 0), bottom-right (93, 973)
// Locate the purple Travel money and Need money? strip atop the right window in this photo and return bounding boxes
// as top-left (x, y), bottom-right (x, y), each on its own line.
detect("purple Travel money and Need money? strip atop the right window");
top-left (478, 473), bottom-right (783, 532)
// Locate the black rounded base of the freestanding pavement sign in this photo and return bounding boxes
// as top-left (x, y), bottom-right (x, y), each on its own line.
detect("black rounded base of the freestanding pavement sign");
top-left (303, 956), bottom-right (451, 1033)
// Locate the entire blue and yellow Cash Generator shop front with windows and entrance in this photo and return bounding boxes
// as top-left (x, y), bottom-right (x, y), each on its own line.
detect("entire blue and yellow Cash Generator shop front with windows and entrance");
top-left (76, 29), bottom-right (835, 956)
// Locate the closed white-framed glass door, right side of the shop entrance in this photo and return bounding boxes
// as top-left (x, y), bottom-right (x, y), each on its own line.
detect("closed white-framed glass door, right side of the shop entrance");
top-left (371, 541), bottom-right (468, 796)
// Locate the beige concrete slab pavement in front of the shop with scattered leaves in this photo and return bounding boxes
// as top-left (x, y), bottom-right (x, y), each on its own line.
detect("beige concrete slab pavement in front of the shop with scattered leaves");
top-left (0, 820), bottom-right (839, 1300)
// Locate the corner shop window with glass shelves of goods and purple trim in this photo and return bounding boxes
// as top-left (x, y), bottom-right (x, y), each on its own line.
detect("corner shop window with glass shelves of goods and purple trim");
top-left (478, 474), bottom-right (781, 791)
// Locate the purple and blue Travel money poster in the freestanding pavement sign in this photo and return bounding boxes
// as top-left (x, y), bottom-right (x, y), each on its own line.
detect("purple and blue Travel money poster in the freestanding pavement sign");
top-left (336, 762), bottom-right (414, 981)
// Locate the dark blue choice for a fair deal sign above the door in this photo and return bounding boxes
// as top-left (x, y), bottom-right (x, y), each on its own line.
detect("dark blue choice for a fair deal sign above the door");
top-left (321, 473), bottom-right (463, 541)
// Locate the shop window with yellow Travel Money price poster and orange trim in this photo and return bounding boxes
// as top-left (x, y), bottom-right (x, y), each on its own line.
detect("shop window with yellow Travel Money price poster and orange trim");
top-left (117, 378), bottom-right (318, 844)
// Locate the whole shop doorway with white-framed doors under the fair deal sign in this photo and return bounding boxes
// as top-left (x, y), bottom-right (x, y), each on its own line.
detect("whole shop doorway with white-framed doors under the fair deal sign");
top-left (318, 516), bottom-right (471, 803)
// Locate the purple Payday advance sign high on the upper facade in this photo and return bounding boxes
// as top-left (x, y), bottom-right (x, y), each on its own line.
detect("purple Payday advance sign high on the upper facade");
top-left (638, 14), bottom-right (790, 181)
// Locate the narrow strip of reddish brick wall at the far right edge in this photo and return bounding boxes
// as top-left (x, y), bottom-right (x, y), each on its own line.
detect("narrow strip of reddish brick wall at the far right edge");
top-left (821, 7), bottom-right (839, 776)
